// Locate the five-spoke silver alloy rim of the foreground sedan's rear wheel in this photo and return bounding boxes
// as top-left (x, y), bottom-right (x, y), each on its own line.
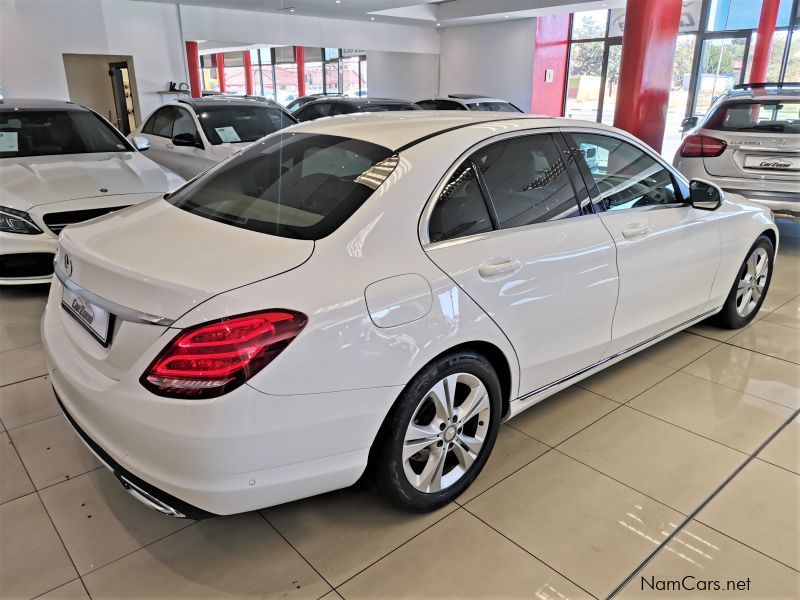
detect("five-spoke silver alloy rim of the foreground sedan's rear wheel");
top-left (403, 373), bottom-right (492, 493)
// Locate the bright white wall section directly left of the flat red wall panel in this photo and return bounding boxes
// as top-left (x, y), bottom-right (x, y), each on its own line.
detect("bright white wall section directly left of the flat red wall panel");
top-left (439, 19), bottom-right (536, 112)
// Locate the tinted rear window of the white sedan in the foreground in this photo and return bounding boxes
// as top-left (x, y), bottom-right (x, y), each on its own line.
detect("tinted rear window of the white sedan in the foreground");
top-left (168, 133), bottom-right (398, 240)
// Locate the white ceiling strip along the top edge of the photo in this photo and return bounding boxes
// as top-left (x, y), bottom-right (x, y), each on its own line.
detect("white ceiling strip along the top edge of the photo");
top-left (130, 0), bottom-right (625, 27)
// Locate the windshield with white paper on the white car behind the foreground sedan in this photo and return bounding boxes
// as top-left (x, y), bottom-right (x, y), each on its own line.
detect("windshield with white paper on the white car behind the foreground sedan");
top-left (195, 104), bottom-right (295, 145)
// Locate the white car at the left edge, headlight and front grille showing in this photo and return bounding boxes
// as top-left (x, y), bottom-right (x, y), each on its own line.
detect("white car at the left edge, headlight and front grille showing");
top-left (0, 99), bottom-right (184, 285)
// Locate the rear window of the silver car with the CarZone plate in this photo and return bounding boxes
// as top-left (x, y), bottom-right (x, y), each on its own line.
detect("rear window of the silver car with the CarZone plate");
top-left (705, 100), bottom-right (800, 134)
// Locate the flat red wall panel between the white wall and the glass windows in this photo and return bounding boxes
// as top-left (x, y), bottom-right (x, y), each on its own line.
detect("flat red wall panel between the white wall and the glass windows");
top-left (531, 15), bottom-right (569, 117)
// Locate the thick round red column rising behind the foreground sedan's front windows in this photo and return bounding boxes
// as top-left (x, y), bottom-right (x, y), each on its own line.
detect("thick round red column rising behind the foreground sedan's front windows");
top-left (614, 0), bottom-right (683, 151)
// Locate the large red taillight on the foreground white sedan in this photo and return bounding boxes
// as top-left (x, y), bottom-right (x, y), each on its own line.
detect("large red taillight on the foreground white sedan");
top-left (141, 309), bottom-right (308, 398)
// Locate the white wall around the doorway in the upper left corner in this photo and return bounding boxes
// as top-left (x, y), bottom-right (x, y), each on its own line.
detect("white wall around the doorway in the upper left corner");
top-left (0, 0), bottom-right (186, 115)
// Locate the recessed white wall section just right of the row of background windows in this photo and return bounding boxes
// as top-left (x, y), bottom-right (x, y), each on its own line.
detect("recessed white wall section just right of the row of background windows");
top-left (367, 51), bottom-right (439, 100)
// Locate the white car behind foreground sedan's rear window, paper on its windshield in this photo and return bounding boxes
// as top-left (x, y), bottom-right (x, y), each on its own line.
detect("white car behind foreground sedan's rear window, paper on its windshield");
top-left (128, 96), bottom-right (297, 179)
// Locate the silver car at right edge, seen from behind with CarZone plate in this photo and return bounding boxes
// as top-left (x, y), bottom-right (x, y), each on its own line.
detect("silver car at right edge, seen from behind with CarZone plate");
top-left (674, 84), bottom-right (800, 217)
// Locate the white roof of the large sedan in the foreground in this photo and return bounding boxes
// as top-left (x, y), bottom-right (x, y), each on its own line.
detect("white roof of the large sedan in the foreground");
top-left (283, 110), bottom-right (604, 150)
